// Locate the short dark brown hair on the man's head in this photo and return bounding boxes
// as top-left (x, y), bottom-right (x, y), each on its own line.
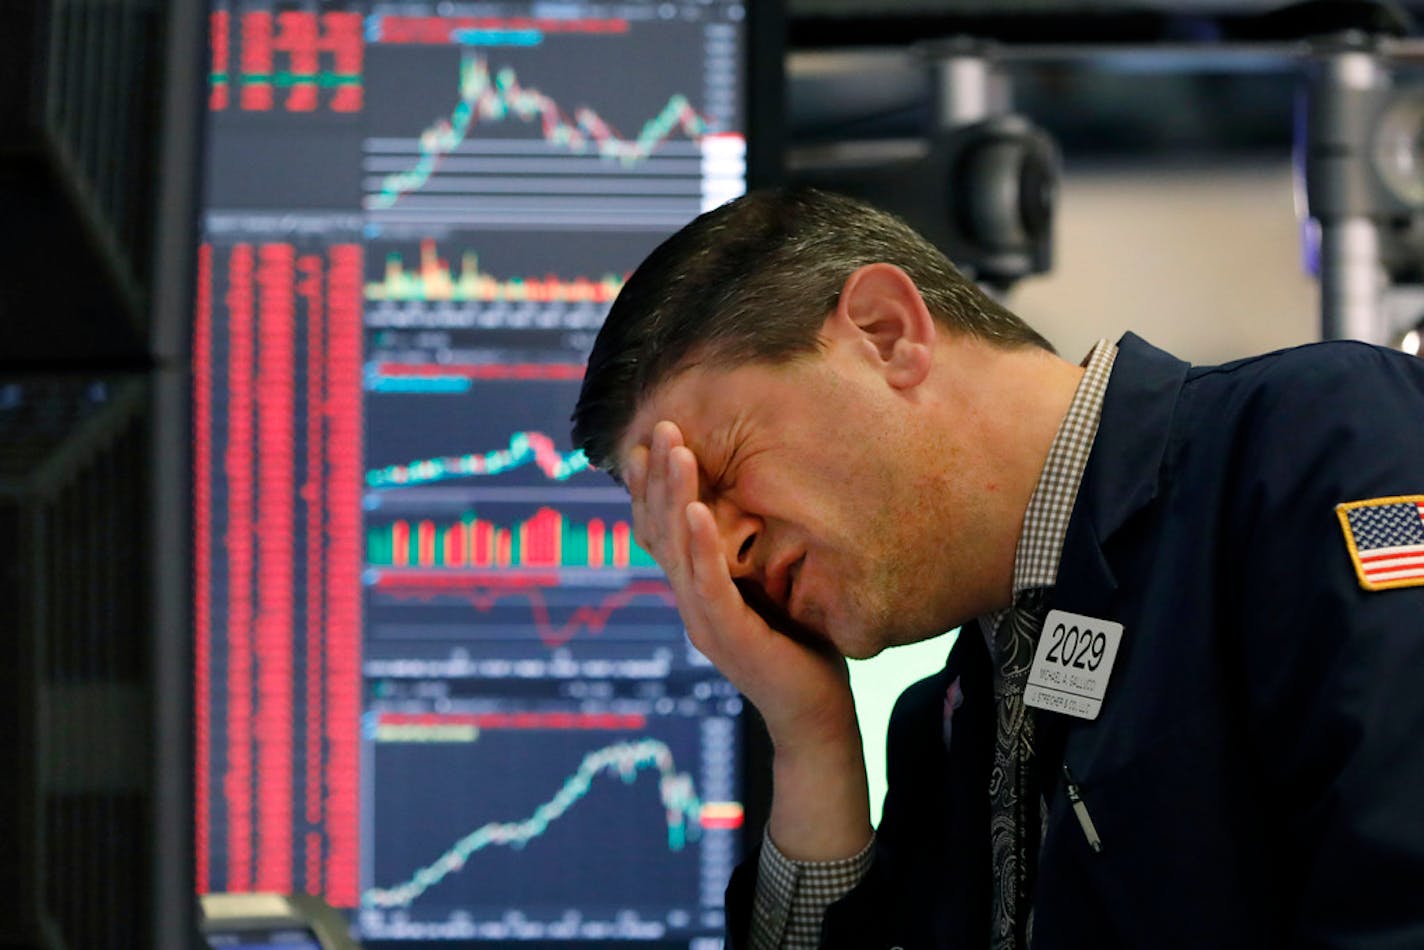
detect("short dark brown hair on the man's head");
top-left (572, 188), bottom-right (1052, 470)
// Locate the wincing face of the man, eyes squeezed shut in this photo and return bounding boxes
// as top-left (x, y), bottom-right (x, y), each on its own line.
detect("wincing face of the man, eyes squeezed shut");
top-left (619, 345), bottom-right (1002, 657)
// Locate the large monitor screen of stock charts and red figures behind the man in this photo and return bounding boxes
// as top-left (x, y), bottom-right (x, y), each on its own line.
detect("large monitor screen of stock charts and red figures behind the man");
top-left (194, 0), bottom-right (780, 947)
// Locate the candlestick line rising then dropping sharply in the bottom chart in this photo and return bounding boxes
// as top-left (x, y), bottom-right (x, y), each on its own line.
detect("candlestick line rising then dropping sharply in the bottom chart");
top-left (362, 739), bottom-right (702, 907)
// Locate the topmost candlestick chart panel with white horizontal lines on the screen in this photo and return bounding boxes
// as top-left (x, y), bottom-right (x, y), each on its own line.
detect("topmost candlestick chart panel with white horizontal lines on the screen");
top-left (363, 24), bottom-right (733, 229)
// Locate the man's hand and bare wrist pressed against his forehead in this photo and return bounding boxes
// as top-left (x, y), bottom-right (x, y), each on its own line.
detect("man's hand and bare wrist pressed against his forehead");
top-left (625, 422), bottom-right (870, 860)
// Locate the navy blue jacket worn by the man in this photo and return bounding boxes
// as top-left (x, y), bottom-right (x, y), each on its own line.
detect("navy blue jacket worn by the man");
top-left (728, 335), bottom-right (1424, 950)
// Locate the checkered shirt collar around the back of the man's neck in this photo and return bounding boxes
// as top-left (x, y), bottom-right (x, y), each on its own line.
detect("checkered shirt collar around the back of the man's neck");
top-left (1014, 339), bottom-right (1118, 598)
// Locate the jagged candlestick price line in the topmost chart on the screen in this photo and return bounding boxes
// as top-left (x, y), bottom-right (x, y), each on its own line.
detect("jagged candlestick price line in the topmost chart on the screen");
top-left (372, 56), bottom-right (708, 208)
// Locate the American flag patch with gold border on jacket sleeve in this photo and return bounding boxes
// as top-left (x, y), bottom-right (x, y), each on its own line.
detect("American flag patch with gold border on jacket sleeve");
top-left (1336, 494), bottom-right (1424, 591)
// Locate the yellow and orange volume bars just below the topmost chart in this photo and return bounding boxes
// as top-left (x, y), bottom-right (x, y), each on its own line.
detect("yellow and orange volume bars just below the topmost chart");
top-left (366, 238), bottom-right (624, 303)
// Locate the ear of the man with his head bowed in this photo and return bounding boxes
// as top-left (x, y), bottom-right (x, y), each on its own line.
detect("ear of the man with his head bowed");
top-left (826, 263), bottom-right (938, 389)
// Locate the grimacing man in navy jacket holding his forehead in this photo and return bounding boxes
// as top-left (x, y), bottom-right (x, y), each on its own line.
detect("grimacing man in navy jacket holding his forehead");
top-left (574, 191), bottom-right (1424, 950)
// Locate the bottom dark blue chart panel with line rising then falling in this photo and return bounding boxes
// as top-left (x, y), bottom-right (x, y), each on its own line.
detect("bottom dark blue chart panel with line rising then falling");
top-left (362, 699), bottom-right (740, 939)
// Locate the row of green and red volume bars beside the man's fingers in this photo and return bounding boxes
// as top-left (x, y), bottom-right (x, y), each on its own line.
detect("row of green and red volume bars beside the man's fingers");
top-left (366, 508), bottom-right (656, 568)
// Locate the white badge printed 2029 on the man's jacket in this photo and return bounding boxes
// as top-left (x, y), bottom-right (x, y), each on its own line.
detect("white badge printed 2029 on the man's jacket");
top-left (1024, 610), bottom-right (1122, 719)
